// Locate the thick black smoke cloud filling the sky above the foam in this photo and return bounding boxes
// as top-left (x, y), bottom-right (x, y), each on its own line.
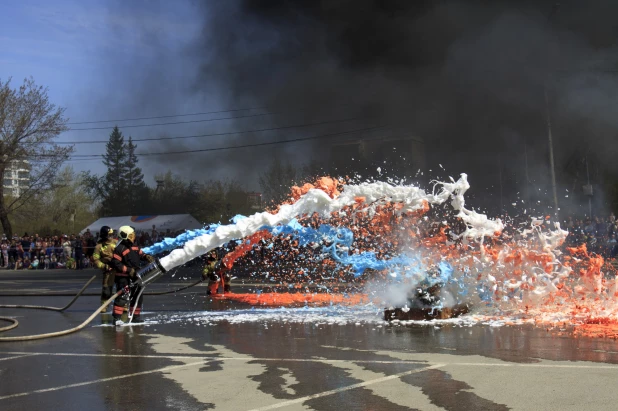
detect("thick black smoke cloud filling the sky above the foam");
top-left (102, 0), bottom-right (618, 217)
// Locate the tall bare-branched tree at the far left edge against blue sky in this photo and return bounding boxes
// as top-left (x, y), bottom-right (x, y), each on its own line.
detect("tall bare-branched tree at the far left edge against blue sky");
top-left (0, 78), bottom-right (73, 238)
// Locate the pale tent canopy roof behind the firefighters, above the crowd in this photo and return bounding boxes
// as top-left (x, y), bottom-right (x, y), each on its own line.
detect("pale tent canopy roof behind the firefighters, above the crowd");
top-left (81, 214), bottom-right (204, 234)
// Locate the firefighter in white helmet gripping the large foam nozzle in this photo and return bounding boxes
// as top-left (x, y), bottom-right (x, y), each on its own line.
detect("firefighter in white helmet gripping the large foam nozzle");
top-left (111, 225), bottom-right (154, 325)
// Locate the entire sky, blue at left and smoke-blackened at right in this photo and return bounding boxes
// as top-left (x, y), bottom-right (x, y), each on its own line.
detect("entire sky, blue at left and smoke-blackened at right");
top-left (0, 0), bottom-right (618, 219)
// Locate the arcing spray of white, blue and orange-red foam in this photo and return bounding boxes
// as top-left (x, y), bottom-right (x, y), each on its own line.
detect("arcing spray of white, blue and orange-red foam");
top-left (149, 174), bottom-right (618, 336)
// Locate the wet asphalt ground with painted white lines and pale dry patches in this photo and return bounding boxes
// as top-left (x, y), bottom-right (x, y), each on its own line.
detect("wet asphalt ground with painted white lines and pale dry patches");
top-left (0, 269), bottom-right (618, 411)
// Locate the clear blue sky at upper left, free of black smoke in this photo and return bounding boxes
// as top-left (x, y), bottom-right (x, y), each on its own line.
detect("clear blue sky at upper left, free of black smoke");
top-left (0, 0), bottom-right (219, 184)
